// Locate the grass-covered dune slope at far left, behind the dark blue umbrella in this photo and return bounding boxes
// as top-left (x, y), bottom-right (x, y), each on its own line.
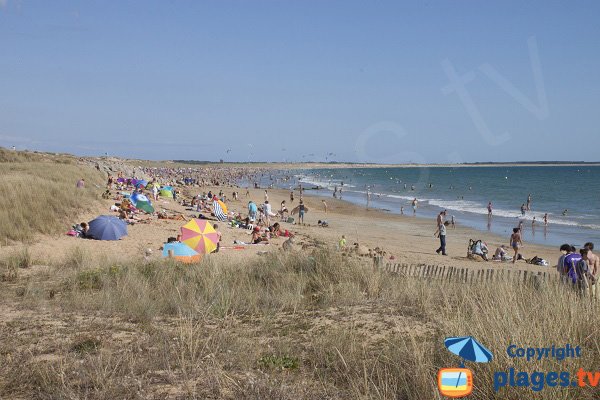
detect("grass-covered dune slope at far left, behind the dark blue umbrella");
top-left (0, 148), bottom-right (104, 243)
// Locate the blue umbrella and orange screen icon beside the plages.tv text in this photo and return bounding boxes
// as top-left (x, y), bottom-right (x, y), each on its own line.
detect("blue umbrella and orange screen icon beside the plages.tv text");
top-left (438, 336), bottom-right (493, 398)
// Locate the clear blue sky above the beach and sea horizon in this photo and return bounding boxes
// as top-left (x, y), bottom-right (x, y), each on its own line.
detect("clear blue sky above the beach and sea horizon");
top-left (0, 0), bottom-right (600, 163)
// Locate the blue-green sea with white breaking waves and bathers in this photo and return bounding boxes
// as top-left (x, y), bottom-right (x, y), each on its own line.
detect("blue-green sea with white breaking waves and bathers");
top-left (252, 165), bottom-right (600, 247)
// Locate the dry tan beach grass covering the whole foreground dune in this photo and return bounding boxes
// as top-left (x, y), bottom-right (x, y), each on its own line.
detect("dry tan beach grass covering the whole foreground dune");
top-left (0, 248), bottom-right (600, 399)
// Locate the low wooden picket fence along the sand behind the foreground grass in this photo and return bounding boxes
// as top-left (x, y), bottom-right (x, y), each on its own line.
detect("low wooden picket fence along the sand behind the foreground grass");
top-left (373, 258), bottom-right (559, 284)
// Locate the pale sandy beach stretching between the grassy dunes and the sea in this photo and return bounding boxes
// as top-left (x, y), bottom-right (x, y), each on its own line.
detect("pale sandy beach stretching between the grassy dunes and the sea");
top-left (0, 173), bottom-right (559, 271)
